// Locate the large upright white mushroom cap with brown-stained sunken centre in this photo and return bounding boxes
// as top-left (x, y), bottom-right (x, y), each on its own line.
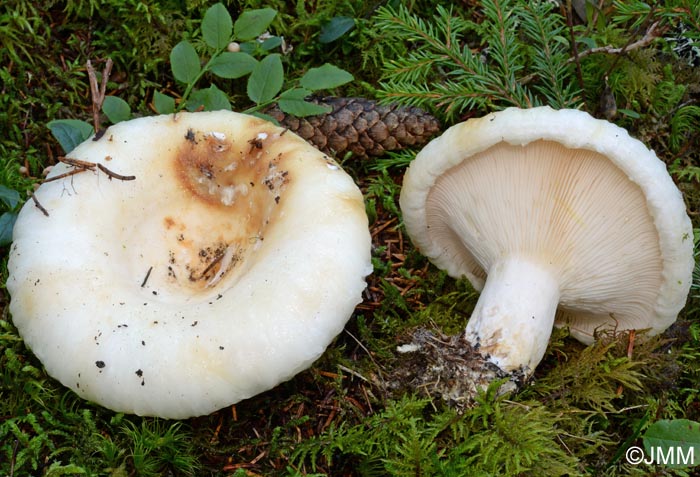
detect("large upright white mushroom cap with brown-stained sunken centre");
top-left (7, 111), bottom-right (371, 418)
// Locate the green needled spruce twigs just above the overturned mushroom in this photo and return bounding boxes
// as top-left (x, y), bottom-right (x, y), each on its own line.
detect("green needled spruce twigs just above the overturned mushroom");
top-left (376, 0), bottom-right (579, 122)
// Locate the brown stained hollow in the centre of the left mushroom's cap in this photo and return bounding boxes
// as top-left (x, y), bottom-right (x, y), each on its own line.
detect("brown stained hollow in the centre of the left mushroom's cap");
top-left (163, 123), bottom-right (292, 288)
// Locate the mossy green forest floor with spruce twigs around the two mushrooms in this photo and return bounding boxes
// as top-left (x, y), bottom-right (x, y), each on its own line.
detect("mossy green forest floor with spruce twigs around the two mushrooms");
top-left (0, 0), bottom-right (700, 477)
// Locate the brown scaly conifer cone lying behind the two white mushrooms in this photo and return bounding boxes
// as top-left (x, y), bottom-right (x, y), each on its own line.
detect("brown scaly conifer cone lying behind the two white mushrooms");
top-left (264, 97), bottom-right (440, 159)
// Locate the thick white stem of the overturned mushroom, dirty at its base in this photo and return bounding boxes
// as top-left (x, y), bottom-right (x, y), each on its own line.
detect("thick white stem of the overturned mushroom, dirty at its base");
top-left (465, 256), bottom-right (559, 375)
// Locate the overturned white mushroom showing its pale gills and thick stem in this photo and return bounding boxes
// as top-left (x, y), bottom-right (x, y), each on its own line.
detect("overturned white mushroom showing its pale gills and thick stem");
top-left (400, 107), bottom-right (693, 371)
